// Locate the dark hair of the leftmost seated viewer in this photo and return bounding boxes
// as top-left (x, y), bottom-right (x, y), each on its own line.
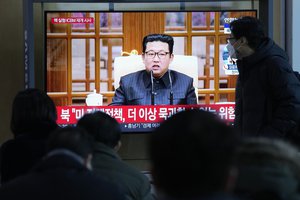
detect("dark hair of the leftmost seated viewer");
top-left (10, 88), bottom-right (57, 136)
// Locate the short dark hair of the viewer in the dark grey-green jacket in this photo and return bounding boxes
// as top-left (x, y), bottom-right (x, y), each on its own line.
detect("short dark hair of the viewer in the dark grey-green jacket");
top-left (77, 111), bottom-right (121, 148)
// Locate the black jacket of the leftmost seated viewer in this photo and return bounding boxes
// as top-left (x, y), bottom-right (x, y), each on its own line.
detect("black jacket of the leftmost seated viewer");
top-left (0, 122), bottom-right (57, 183)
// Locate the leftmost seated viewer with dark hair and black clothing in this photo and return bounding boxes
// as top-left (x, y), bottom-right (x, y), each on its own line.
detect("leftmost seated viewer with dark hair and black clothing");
top-left (0, 89), bottom-right (57, 183)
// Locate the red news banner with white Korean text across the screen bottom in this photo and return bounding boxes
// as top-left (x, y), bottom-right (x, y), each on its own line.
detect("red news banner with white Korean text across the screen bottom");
top-left (57, 104), bottom-right (235, 132)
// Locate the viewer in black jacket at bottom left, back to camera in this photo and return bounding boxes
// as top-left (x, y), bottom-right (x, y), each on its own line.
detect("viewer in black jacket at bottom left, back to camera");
top-left (0, 128), bottom-right (125, 200)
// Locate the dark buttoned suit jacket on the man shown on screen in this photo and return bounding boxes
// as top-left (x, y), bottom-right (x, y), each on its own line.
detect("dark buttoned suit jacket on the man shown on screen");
top-left (110, 70), bottom-right (197, 105)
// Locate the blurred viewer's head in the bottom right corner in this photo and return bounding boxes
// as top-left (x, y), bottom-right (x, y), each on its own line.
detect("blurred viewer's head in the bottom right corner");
top-left (235, 138), bottom-right (300, 200)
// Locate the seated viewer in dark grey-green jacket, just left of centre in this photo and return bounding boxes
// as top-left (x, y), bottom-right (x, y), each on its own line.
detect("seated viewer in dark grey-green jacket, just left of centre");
top-left (77, 111), bottom-right (153, 200)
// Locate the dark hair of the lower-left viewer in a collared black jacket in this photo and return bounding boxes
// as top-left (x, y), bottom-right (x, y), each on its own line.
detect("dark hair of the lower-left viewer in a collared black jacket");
top-left (46, 126), bottom-right (93, 158)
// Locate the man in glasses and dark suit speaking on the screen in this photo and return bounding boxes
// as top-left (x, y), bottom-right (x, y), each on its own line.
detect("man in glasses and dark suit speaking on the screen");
top-left (110, 34), bottom-right (197, 105)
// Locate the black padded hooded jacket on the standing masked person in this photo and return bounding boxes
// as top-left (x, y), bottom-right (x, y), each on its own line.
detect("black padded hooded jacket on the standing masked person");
top-left (234, 38), bottom-right (300, 138)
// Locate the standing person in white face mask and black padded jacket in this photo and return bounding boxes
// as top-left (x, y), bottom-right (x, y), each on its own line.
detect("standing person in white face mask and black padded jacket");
top-left (231, 16), bottom-right (300, 143)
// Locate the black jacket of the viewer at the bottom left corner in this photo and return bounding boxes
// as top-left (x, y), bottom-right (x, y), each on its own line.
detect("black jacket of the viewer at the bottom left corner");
top-left (0, 152), bottom-right (125, 200)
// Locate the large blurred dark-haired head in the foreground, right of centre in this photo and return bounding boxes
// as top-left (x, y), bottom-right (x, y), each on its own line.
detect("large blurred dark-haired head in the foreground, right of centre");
top-left (149, 110), bottom-right (238, 198)
